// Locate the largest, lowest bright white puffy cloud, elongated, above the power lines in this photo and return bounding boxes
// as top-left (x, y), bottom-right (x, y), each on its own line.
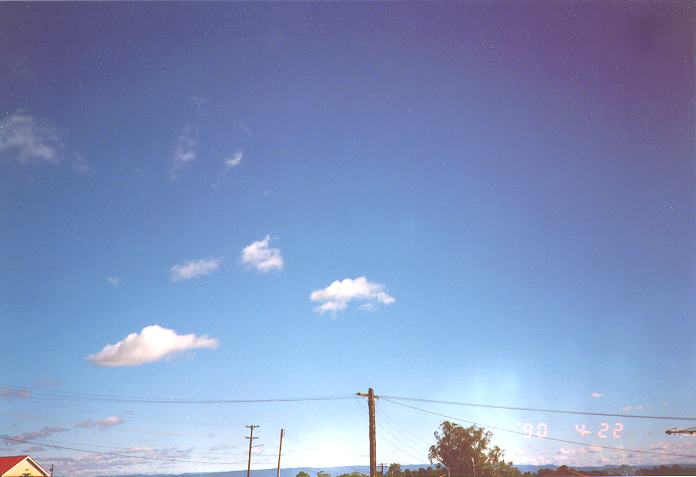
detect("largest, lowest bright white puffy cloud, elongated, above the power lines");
top-left (87, 325), bottom-right (219, 368)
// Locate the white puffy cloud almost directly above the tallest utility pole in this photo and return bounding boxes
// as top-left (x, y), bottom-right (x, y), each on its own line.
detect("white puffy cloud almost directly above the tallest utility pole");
top-left (309, 277), bottom-right (396, 315)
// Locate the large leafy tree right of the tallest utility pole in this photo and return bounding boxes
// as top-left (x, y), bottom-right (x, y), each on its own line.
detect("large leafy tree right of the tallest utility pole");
top-left (428, 421), bottom-right (521, 477)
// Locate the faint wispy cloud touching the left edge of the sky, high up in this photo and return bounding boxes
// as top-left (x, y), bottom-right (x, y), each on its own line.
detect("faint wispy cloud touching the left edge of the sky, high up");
top-left (0, 110), bottom-right (65, 164)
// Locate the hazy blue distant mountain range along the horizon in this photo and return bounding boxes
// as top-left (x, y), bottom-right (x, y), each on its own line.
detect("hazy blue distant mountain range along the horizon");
top-left (103, 463), bottom-right (696, 477)
